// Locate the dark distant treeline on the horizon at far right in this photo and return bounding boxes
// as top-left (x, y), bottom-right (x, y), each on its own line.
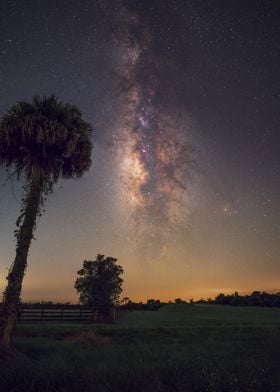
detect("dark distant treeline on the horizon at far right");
top-left (196, 291), bottom-right (280, 307)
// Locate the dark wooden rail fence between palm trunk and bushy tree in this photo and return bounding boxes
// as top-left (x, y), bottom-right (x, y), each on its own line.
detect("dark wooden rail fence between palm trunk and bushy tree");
top-left (18, 305), bottom-right (94, 323)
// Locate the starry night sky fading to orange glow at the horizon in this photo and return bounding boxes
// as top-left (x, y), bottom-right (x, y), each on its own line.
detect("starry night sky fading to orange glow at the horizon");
top-left (0, 0), bottom-right (280, 302)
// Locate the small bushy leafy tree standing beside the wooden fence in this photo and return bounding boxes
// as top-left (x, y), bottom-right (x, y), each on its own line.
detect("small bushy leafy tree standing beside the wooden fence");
top-left (75, 254), bottom-right (123, 316)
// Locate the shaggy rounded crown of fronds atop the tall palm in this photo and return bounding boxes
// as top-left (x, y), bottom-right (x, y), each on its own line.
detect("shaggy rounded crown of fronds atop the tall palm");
top-left (0, 95), bottom-right (92, 187)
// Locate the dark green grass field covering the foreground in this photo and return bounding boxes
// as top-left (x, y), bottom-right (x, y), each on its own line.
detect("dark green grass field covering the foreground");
top-left (0, 304), bottom-right (280, 392)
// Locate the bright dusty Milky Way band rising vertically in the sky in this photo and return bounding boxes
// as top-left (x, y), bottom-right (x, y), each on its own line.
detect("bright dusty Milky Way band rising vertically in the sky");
top-left (112, 5), bottom-right (197, 254)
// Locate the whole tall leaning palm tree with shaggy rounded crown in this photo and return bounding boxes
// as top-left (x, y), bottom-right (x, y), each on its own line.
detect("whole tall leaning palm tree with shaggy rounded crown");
top-left (0, 95), bottom-right (92, 352)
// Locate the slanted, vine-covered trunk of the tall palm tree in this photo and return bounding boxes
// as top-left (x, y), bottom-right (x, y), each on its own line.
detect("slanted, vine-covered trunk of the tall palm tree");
top-left (0, 174), bottom-right (43, 353)
